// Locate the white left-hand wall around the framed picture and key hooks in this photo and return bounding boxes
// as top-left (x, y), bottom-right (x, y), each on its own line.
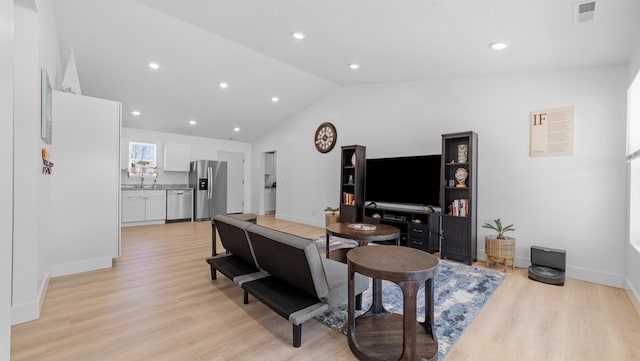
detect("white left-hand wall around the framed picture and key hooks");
top-left (12, 0), bottom-right (60, 324)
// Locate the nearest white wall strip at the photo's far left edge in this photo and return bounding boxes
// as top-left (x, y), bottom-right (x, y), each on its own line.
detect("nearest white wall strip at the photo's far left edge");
top-left (0, 0), bottom-right (14, 354)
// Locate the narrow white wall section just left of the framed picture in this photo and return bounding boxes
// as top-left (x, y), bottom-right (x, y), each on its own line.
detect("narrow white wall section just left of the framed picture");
top-left (12, 3), bottom-right (43, 323)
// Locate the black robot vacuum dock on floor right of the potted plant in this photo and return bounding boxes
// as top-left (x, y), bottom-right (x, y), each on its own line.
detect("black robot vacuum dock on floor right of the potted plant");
top-left (529, 246), bottom-right (567, 286)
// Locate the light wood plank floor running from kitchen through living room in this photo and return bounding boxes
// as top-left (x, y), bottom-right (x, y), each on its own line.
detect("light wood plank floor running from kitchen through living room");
top-left (11, 215), bottom-right (640, 361)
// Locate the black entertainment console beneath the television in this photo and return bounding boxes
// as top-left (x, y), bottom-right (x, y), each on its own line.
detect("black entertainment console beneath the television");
top-left (363, 203), bottom-right (440, 253)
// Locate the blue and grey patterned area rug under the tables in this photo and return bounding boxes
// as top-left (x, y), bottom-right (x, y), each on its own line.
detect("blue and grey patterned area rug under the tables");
top-left (316, 238), bottom-right (504, 360)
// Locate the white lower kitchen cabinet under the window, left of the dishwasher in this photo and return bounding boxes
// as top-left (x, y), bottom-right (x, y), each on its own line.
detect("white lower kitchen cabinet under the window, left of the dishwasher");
top-left (121, 190), bottom-right (167, 225)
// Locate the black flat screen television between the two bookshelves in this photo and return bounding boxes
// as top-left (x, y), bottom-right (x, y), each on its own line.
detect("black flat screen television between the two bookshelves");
top-left (365, 154), bottom-right (441, 207)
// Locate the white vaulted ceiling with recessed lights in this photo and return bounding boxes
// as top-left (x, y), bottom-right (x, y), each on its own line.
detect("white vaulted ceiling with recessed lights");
top-left (53, 0), bottom-right (640, 142)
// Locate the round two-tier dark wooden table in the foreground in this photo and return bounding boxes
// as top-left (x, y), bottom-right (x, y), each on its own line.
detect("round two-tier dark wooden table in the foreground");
top-left (347, 245), bottom-right (439, 361)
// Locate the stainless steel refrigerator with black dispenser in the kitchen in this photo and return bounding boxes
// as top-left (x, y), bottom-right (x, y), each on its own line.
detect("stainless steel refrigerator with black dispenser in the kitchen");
top-left (189, 160), bottom-right (227, 221)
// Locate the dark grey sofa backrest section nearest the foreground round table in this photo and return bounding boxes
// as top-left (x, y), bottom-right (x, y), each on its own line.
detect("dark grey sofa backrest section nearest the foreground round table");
top-left (247, 225), bottom-right (330, 302)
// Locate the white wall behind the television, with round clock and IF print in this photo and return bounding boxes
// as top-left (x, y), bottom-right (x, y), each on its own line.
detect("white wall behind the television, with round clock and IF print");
top-left (252, 66), bottom-right (627, 287)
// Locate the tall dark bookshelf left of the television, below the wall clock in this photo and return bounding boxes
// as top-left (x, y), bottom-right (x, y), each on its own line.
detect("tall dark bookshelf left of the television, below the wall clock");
top-left (340, 145), bottom-right (366, 222)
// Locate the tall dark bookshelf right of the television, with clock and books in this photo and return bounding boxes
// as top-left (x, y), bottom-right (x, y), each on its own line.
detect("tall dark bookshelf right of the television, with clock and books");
top-left (440, 131), bottom-right (478, 265)
